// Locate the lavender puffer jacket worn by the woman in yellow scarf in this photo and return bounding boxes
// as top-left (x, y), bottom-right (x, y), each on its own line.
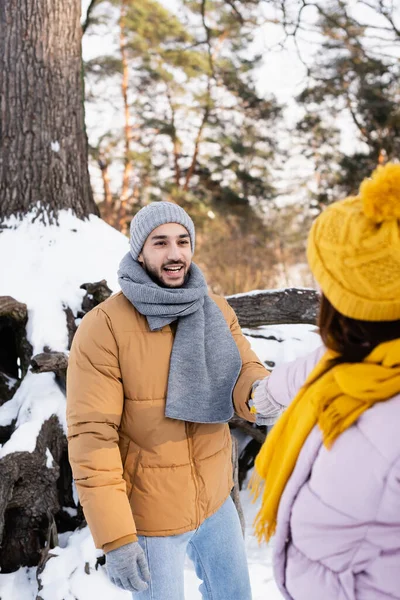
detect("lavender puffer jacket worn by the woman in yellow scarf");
top-left (268, 349), bottom-right (400, 600)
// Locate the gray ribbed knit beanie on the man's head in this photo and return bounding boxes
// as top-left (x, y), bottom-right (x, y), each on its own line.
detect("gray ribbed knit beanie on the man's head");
top-left (130, 202), bottom-right (195, 260)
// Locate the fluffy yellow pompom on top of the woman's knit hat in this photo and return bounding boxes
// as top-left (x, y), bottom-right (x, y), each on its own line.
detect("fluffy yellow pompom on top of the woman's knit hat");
top-left (360, 163), bottom-right (400, 223)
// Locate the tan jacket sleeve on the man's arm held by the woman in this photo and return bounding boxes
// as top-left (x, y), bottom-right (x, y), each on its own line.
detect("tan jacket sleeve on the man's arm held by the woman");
top-left (226, 303), bottom-right (269, 423)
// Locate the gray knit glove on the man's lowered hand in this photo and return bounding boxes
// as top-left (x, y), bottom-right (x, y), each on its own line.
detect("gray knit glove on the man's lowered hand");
top-left (106, 542), bottom-right (150, 592)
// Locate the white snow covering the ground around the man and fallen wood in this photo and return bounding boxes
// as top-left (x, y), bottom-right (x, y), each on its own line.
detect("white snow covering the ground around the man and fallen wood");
top-left (0, 211), bottom-right (320, 600)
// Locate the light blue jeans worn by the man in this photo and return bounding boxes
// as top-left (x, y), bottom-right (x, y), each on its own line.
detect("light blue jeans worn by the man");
top-left (133, 497), bottom-right (251, 600)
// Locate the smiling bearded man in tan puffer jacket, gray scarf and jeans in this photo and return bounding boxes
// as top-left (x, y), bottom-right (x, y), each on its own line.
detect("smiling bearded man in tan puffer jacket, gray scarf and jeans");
top-left (67, 202), bottom-right (267, 600)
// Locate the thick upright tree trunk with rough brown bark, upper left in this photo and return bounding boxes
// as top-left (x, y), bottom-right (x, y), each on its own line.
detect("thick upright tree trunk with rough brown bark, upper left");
top-left (0, 0), bottom-right (98, 222)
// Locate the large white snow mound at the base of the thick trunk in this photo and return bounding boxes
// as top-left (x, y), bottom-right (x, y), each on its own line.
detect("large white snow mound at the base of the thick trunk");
top-left (0, 210), bottom-right (129, 354)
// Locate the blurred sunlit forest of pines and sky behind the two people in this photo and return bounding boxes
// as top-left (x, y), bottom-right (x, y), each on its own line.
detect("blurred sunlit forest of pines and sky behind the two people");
top-left (83, 0), bottom-right (400, 294)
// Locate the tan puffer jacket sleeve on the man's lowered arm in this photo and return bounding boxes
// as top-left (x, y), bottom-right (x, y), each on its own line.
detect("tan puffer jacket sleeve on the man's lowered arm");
top-left (67, 308), bottom-right (137, 551)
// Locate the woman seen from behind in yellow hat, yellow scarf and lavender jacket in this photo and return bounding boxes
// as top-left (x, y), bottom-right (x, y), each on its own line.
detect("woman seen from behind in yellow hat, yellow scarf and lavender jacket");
top-left (252, 163), bottom-right (400, 600)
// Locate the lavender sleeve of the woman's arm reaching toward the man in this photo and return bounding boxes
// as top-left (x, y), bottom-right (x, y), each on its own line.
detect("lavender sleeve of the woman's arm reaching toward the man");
top-left (266, 346), bottom-right (326, 407)
